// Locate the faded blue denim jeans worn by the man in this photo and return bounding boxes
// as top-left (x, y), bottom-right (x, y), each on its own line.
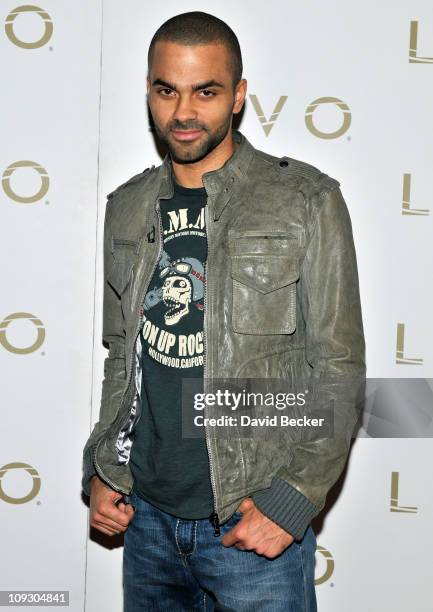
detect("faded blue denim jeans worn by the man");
top-left (123, 493), bottom-right (317, 612)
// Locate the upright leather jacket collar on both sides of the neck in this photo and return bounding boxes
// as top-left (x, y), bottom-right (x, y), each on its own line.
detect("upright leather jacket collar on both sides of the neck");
top-left (157, 129), bottom-right (255, 220)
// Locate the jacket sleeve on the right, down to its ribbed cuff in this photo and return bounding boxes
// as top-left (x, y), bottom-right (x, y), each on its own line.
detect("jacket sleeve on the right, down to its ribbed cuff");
top-left (252, 186), bottom-right (366, 539)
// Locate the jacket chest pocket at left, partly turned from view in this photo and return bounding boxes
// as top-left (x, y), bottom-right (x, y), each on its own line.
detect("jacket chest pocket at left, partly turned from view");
top-left (107, 236), bottom-right (139, 310)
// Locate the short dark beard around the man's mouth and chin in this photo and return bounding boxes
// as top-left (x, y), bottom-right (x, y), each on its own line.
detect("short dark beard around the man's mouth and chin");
top-left (154, 112), bottom-right (232, 164)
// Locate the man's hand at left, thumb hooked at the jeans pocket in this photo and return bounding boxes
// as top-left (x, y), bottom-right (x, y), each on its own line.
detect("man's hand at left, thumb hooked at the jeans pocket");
top-left (90, 476), bottom-right (134, 535)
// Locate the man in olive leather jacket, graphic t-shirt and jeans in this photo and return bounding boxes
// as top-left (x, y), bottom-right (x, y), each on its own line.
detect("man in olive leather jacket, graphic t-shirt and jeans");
top-left (83, 12), bottom-right (365, 612)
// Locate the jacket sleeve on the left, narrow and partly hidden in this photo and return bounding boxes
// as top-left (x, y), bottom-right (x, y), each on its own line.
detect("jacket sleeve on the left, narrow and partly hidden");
top-left (82, 198), bottom-right (126, 495)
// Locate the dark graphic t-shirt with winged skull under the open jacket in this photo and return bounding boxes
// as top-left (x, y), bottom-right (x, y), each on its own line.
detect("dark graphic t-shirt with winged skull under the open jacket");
top-left (130, 183), bottom-right (213, 519)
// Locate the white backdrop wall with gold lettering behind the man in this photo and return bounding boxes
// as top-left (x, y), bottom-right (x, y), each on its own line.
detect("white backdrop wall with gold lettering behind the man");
top-left (0, 0), bottom-right (433, 612)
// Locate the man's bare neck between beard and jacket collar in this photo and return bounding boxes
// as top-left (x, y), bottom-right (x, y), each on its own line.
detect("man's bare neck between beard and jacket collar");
top-left (172, 129), bottom-right (238, 187)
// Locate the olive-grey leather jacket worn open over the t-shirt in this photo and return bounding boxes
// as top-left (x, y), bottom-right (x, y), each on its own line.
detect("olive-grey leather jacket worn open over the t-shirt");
top-left (82, 130), bottom-right (366, 539)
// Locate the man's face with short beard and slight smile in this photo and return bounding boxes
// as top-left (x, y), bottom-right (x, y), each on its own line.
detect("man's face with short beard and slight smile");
top-left (147, 41), bottom-right (246, 163)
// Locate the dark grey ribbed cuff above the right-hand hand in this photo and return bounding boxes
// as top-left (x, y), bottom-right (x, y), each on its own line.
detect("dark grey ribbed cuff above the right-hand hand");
top-left (251, 476), bottom-right (319, 540)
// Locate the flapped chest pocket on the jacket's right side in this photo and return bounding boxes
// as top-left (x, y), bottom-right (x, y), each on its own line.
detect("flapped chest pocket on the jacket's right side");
top-left (230, 231), bottom-right (299, 335)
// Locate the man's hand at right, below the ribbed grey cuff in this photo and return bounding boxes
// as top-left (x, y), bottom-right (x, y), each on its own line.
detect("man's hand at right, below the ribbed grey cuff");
top-left (221, 497), bottom-right (295, 559)
